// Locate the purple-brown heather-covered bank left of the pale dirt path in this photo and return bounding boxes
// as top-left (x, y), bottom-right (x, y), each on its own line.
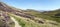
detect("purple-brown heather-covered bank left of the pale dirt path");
top-left (0, 12), bottom-right (15, 27)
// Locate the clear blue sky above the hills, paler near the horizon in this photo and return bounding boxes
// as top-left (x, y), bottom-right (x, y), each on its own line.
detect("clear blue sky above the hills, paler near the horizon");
top-left (1, 0), bottom-right (60, 10)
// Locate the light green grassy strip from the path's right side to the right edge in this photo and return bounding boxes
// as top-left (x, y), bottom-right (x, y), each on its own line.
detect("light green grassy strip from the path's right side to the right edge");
top-left (9, 14), bottom-right (60, 27)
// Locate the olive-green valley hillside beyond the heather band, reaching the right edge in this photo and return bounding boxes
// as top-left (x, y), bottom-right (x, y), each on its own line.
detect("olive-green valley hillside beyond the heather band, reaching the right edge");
top-left (24, 9), bottom-right (60, 23)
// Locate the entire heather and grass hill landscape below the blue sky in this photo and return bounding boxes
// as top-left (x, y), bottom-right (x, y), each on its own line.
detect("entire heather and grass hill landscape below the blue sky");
top-left (0, 2), bottom-right (60, 27)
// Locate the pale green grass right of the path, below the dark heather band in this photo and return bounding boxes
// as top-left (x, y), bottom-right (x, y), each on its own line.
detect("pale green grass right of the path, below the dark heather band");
top-left (10, 14), bottom-right (60, 27)
